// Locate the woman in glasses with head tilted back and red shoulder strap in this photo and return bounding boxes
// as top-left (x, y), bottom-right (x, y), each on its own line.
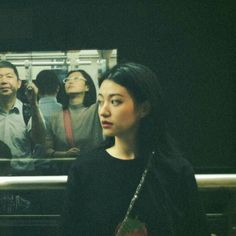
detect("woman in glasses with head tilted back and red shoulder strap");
top-left (46, 70), bottom-right (103, 157)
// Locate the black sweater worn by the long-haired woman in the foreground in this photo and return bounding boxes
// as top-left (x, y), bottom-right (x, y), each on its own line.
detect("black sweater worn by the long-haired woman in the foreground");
top-left (63, 148), bottom-right (209, 236)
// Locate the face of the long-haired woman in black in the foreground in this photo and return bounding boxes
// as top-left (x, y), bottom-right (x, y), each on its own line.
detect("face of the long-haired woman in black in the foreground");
top-left (98, 80), bottom-right (142, 137)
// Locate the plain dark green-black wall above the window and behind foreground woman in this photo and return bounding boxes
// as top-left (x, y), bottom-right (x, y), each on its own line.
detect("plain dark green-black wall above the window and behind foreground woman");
top-left (0, 0), bottom-right (236, 172)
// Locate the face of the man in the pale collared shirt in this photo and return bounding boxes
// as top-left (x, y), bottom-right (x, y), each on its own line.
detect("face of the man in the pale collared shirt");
top-left (0, 68), bottom-right (21, 96)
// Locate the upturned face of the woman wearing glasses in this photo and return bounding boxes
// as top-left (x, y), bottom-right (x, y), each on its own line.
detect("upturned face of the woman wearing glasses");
top-left (65, 72), bottom-right (88, 94)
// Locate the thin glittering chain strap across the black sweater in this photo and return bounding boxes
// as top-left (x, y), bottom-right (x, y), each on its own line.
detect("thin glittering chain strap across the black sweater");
top-left (115, 151), bottom-right (155, 236)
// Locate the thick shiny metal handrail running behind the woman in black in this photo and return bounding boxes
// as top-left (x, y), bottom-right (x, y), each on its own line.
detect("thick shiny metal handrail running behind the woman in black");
top-left (0, 174), bottom-right (236, 190)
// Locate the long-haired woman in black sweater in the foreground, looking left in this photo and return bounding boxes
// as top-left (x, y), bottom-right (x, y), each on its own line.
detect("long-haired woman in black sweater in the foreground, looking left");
top-left (63, 63), bottom-right (208, 236)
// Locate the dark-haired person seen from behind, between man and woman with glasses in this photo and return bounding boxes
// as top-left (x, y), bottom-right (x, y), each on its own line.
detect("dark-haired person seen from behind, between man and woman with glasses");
top-left (35, 70), bottom-right (62, 124)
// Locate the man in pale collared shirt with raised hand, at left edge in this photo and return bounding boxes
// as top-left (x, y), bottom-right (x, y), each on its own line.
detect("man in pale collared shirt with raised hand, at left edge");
top-left (0, 61), bottom-right (45, 174)
